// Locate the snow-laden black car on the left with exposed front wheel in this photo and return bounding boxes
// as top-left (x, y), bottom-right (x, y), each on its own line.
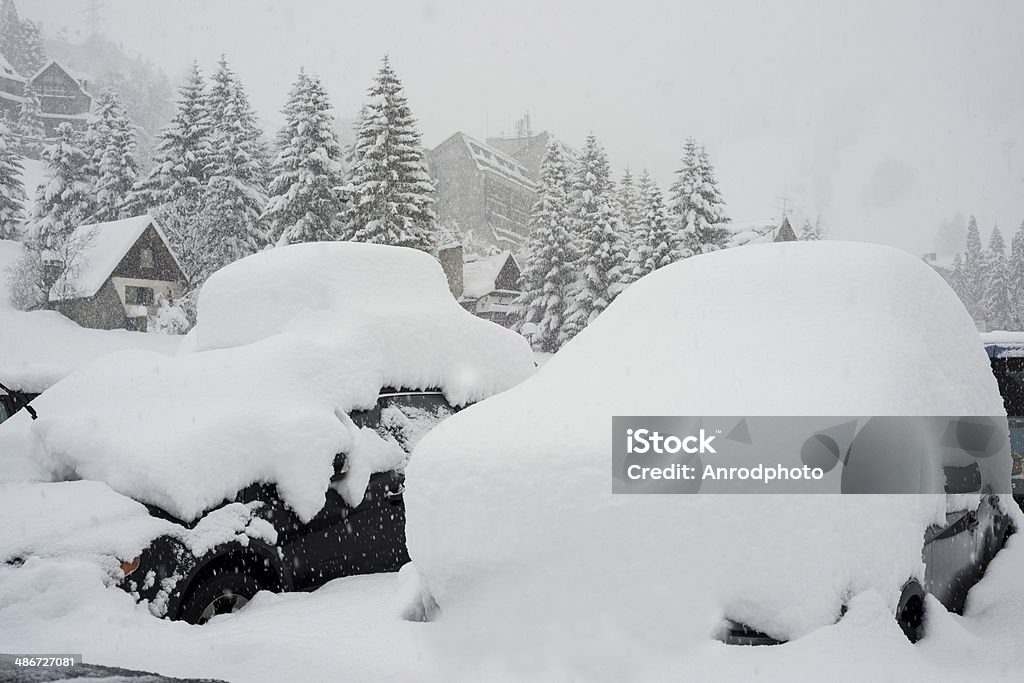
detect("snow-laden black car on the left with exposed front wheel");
top-left (0, 243), bottom-right (534, 623)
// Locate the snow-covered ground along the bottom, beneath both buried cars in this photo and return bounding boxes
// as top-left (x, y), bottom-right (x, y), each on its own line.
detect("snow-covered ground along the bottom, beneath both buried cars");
top-left (0, 535), bottom-right (1024, 683)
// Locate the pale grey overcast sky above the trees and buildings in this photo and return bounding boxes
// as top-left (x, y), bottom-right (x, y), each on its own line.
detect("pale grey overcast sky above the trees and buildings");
top-left (17, 0), bottom-right (1024, 253)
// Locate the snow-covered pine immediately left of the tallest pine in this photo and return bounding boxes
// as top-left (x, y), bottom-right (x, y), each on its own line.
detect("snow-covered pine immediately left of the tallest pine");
top-left (263, 72), bottom-right (344, 245)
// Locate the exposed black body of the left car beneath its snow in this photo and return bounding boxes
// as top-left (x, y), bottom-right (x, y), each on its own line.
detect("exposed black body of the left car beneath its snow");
top-left (121, 390), bottom-right (455, 624)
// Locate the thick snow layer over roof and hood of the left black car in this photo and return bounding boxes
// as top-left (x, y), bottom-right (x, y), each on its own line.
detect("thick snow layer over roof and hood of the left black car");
top-left (0, 243), bottom-right (534, 520)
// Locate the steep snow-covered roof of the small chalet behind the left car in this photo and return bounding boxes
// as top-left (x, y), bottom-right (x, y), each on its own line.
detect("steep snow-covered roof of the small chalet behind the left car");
top-left (50, 215), bottom-right (183, 301)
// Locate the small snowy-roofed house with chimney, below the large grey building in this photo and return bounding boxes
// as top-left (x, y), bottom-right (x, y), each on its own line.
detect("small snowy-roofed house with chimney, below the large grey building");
top-left (437, 245), bottom-right (522, 327)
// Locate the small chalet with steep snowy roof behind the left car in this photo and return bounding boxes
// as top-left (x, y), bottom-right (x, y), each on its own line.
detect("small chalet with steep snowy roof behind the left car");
top-left (50, 216), bottom-right (186, 332)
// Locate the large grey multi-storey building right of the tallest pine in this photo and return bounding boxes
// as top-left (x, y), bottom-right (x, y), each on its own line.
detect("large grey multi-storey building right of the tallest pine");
top-left (425, 133), bottom-right (537, 250)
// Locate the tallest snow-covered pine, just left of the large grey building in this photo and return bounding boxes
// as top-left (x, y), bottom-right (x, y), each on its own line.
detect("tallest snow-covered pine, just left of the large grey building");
top-left (345, 56), bottom-right (436, 251)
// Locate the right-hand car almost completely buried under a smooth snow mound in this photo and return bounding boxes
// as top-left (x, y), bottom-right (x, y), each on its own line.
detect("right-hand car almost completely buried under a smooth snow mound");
top-left (406, 242), bottom-right (1024, 656)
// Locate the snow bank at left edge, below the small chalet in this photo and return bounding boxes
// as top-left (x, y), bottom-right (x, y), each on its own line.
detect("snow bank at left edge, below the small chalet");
top-left (0, 240), bottom-right (181, 393)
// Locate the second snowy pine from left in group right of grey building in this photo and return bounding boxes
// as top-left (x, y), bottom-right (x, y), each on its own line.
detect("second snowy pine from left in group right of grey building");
top-left (561, 134), bottom-right (628, 342)
